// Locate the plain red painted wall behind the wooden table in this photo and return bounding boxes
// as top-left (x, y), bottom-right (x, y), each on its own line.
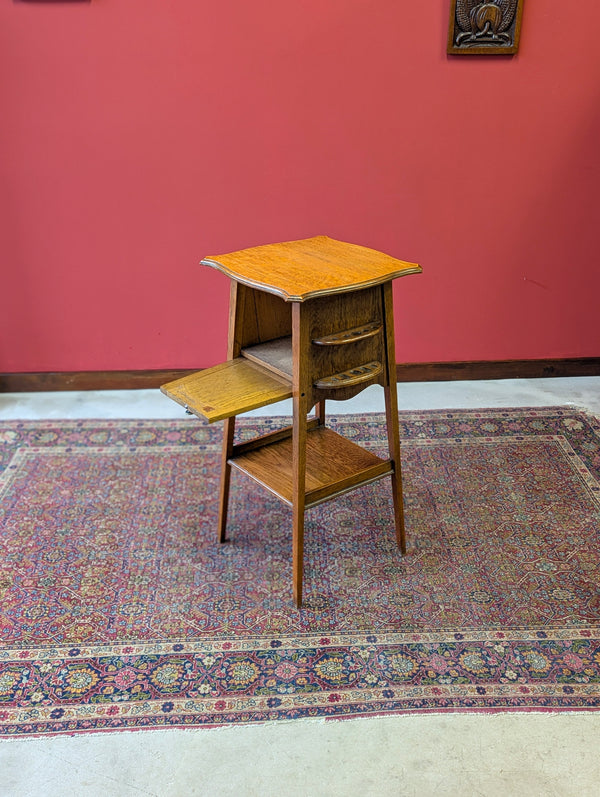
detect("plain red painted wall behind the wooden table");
top-left (0, 0), bottom-right (600, 372)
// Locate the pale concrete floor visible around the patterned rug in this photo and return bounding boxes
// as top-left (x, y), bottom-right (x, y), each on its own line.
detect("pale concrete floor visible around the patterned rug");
top-left (0, 377), bottom-right (600, 797)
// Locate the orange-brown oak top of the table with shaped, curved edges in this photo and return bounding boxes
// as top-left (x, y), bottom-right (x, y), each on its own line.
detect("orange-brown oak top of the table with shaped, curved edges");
top-left (201, 235), bottom-right (422, 302)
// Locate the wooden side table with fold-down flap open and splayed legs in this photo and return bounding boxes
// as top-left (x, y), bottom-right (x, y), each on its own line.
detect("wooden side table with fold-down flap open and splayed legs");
top-left (161, 236), bottom-right (421, 607)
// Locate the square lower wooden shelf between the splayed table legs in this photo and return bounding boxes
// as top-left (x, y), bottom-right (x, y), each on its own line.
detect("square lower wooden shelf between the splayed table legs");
top-left (230, 426), bottom-right (393, 507)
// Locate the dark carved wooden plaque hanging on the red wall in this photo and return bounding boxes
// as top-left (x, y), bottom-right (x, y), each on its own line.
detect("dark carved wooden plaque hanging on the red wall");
top-left (448, 0), bottom-right (523, 55)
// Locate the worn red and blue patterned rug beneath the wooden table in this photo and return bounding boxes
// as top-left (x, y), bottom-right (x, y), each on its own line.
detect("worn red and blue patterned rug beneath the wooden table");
top-left (0, 408), bottom-right (600, 736)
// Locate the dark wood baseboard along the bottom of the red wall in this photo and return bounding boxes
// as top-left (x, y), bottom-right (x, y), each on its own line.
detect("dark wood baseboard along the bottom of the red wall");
top-left (0, 357), bottom-right (600, 393)
